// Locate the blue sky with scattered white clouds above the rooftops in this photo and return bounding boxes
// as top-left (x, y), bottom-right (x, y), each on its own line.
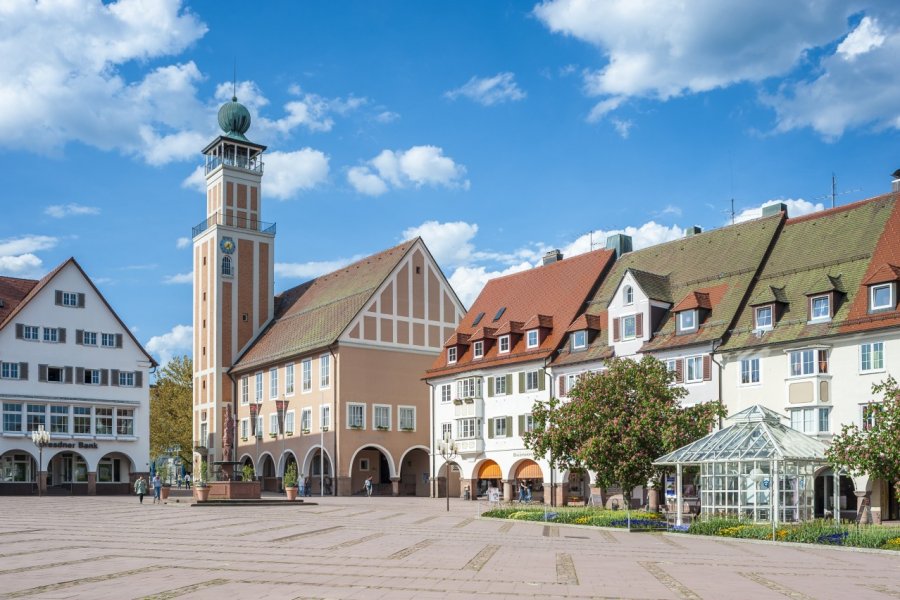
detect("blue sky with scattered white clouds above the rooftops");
top-left (0, 0), bottom-right (900, 359)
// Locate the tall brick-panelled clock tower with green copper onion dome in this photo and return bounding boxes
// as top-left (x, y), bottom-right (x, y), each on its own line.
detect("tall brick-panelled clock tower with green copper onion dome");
top-left (192, 98), bottom-right (275, 474)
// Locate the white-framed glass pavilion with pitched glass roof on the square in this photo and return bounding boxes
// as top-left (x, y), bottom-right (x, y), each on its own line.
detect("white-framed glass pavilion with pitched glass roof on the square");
top-left (653, 405), bottom-right (828, 525)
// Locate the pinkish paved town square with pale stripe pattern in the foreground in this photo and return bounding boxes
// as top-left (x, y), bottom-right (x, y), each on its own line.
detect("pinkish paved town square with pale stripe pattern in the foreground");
top-left (0, 497), bottom-right (900, 600)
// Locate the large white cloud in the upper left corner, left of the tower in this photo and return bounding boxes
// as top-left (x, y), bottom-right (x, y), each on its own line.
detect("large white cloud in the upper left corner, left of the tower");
top-left (0, 0), bottom-right (208, 163)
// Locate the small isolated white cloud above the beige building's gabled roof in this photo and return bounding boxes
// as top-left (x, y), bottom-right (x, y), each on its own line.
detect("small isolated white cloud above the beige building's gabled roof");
top-left (347, 146), bottom-right (470, 196)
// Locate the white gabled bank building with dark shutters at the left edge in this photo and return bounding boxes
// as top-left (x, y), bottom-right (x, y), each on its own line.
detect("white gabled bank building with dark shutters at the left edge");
top-left (0, 258), bottom-right (156, 494)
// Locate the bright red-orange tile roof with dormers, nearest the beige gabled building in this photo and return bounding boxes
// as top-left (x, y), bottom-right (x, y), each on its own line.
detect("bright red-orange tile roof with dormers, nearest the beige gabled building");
top-left (426, 250), bottom-right (615, 378)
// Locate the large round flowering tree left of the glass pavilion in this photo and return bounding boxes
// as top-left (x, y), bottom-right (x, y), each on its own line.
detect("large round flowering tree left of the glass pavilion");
top-left (523, 356), bottom-right (724, 506)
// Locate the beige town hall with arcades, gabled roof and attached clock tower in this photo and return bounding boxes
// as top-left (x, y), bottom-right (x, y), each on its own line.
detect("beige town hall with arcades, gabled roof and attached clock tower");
top-left (194, 95), bottom-right (464, 496)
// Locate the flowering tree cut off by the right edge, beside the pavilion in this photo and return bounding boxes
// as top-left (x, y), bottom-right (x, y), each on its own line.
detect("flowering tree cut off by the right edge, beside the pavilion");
top-left (827, 376), bottom-right (900, 493)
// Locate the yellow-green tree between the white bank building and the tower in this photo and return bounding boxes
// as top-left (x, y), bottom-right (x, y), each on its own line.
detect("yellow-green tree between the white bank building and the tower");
top-left (150, 356), bottom-right (194, 468)
